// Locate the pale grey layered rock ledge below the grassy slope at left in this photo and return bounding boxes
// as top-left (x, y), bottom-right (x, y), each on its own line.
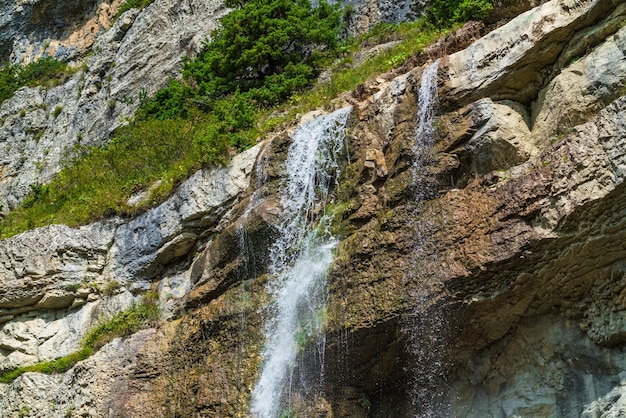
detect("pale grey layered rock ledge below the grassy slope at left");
top-left (0, 145), bottom-right (261, 370)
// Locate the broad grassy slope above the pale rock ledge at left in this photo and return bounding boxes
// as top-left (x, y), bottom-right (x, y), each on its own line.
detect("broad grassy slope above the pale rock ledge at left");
top-left (0, 100), bottom-right (258, 238)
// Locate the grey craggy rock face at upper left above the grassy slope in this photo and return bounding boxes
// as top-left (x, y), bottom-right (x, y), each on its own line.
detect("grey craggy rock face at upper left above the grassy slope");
top-left (0, 0), bottom-right (227, 213)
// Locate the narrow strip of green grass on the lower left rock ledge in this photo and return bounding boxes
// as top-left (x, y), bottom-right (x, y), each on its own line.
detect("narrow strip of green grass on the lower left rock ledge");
top-left (0, 295), bottom-right (160, 383)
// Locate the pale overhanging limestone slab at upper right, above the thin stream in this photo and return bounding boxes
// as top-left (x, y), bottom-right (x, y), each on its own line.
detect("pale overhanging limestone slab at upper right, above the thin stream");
top-left (441, 0), bottom-right (614, 105)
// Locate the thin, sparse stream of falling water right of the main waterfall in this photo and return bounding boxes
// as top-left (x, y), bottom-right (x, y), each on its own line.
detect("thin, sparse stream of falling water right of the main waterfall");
top-left (405, 61), bottom-right (447, 417)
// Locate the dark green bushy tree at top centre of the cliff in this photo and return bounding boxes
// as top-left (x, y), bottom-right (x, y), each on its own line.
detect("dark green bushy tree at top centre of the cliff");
top-left (183, 0), bottom-right (341, 105)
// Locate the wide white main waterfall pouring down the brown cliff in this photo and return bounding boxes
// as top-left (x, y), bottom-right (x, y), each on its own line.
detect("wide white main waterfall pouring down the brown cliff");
top-left (251, 107), bottom-right (352, 418)
